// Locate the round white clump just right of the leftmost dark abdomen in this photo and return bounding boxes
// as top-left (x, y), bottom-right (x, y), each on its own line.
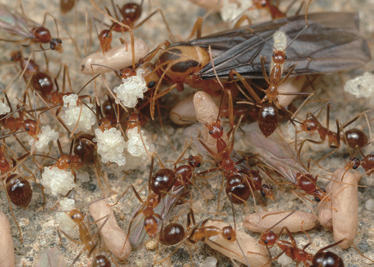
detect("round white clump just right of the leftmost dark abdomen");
top-left (41, 167), bottom-right (75, 196)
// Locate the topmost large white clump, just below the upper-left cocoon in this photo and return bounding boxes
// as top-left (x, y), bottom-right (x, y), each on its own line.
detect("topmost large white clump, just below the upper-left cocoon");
top-left (113, 69), bottom-right (148, 108)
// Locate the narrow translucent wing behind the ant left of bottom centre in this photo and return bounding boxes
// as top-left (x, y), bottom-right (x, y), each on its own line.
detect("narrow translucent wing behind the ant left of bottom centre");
top-left (129, 186), bottom-right (184, 249)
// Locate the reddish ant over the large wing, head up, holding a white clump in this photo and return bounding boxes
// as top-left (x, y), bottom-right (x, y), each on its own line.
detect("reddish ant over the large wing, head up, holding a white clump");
top-left (229, 0), bottom-right (311, 137)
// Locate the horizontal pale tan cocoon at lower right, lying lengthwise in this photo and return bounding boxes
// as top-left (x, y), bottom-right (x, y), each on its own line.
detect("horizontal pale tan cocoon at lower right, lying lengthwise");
top-left (243, 210), bottom-right (318, 234)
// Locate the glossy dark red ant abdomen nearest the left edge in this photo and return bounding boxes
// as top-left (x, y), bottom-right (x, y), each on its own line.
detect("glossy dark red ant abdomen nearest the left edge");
top-left (6, 174), bottom-right (32, 208)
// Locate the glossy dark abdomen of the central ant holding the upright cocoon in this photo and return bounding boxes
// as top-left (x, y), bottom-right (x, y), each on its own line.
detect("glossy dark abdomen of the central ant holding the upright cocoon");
top-left (226, 175), bottom-right (251, 204)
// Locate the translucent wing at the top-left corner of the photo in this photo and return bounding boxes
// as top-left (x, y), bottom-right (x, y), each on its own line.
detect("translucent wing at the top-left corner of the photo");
top-left (0, 4), bottom-right (40, 38)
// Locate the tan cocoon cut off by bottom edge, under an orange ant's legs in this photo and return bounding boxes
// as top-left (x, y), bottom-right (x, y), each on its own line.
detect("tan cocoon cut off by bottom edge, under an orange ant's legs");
top-left (204, 221), bottom-right (270, 267)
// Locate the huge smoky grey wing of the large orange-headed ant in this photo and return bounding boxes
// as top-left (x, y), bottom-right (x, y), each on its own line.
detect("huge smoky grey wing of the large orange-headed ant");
top-left (196, 12), bottom-right (371, 79)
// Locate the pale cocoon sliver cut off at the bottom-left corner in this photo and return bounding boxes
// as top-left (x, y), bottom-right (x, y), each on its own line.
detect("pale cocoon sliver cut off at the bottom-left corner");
top-left (0, 211), bottom-right (14, 267)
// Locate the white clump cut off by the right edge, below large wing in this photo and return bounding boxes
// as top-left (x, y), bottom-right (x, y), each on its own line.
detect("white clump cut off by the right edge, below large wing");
top-left (344, 72), bottom-right (374, 98)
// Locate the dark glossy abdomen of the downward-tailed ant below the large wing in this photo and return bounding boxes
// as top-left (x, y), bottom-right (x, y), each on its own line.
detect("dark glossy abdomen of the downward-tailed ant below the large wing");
top-left (258, 103), bottom-right (279, 137)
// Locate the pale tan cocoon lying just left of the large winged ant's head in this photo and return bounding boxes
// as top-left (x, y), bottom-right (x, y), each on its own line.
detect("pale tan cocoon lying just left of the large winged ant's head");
top-left (80, 38), bottom-right (149, 75)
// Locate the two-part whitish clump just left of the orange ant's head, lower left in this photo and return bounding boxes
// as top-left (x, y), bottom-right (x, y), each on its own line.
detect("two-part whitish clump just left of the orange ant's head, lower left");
top-left (56, 198), bottom-right (78, 237)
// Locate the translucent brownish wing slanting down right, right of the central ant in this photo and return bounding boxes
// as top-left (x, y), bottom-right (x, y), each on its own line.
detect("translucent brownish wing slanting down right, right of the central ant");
top-left (243, 124), bottom-right (308, 184)
